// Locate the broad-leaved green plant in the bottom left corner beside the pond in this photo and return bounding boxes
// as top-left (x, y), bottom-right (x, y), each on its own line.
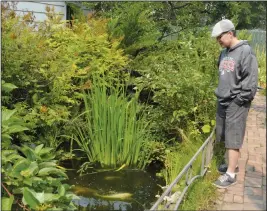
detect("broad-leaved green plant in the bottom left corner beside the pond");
top-left (1, 144), bottom-right (77, 210)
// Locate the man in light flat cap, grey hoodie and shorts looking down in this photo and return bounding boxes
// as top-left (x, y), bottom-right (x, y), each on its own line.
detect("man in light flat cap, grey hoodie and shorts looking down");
top-left (211, 19), bottom-right (258, 188)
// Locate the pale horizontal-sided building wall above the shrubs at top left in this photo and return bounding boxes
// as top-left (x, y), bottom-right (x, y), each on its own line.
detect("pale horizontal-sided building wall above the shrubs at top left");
top-left (15, 1), bottom-right (67, 22)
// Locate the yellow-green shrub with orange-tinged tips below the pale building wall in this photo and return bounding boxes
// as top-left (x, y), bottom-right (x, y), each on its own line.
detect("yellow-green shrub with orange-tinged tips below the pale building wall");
top-left (1, 4), bottom-right (127, 147)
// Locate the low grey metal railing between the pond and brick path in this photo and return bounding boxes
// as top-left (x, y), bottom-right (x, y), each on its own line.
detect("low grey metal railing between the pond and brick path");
top-left (150, 127), bottom-right (215, 211)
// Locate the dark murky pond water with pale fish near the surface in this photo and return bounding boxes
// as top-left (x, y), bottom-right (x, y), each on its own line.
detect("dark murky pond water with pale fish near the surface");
top-left (63, 161), bottom-right (164, 210)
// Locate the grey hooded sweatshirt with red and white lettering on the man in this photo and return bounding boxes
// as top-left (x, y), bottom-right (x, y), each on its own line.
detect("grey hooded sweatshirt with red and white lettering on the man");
top-left (215, 40), bottom-right (258, 106)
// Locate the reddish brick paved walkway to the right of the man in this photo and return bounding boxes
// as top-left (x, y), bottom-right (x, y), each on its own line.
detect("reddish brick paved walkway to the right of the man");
top-left (216, 93), bottom-right (266, 210)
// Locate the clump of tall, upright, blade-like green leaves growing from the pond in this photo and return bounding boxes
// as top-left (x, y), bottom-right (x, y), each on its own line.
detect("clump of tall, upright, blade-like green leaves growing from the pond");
top-left (74, 78), bottom-right (149, 169)
